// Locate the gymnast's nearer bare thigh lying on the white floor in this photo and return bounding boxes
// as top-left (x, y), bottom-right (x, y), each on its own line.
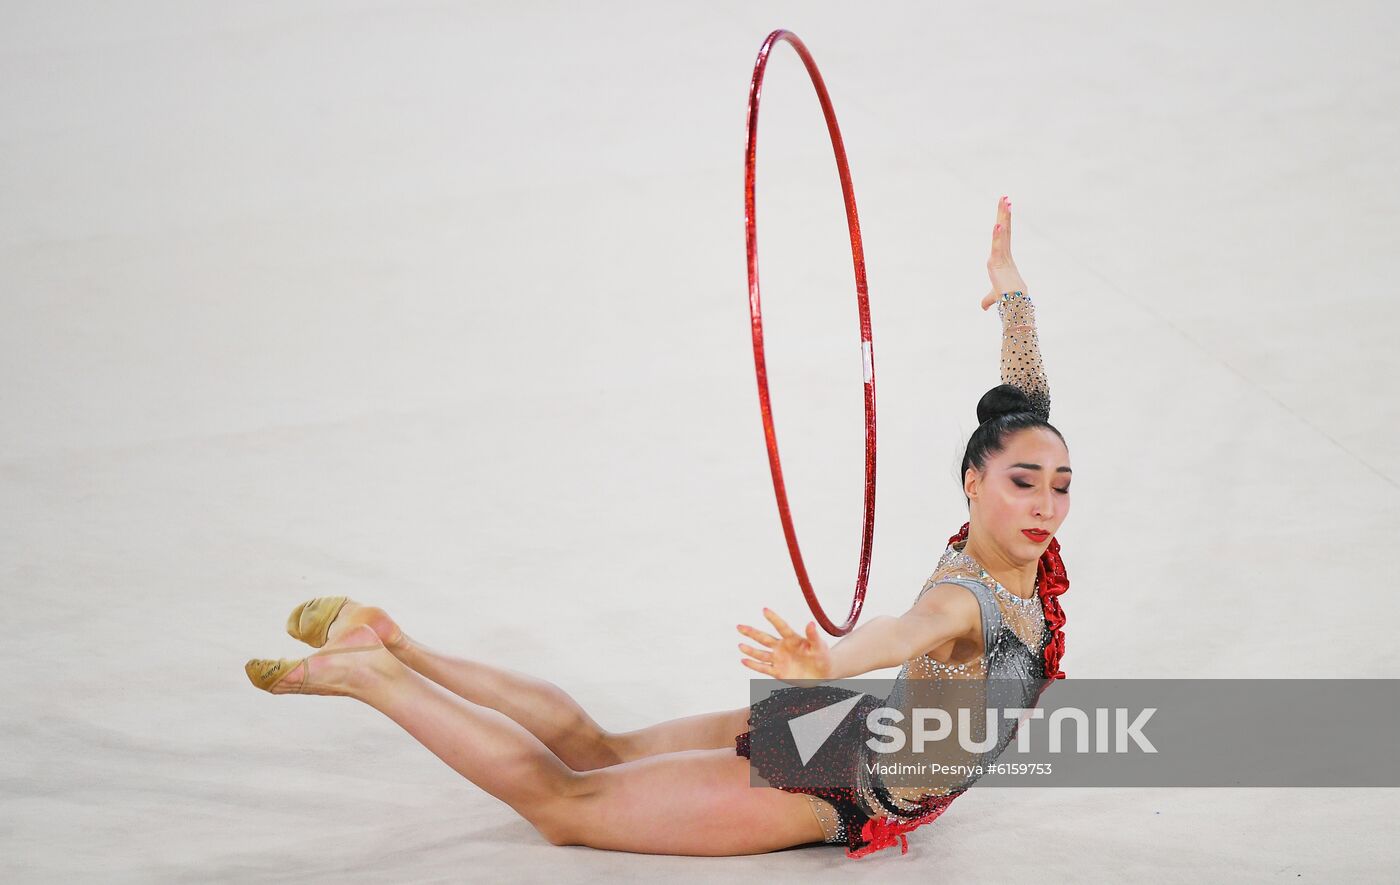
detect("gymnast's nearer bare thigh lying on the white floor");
top-left (556, 748), bottom-right (826, 857)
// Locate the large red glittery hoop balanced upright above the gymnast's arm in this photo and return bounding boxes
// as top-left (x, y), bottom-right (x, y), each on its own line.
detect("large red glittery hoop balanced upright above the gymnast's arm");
top-left (743, 28), bottom-right (875, 636)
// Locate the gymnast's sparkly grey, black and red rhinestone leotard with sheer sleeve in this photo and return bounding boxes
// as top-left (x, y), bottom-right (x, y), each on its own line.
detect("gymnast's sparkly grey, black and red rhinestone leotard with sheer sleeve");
top-left (735, 293), bottom-right (1050, 857)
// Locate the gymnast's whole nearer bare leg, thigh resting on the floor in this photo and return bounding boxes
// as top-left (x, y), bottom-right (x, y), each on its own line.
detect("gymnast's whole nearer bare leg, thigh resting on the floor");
top-left (274, 626), bottom-right (822, 856)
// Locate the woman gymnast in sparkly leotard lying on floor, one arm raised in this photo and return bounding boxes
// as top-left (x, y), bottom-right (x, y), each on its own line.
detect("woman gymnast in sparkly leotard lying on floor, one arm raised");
top-left (245, 197), bottom-right (1071, 857)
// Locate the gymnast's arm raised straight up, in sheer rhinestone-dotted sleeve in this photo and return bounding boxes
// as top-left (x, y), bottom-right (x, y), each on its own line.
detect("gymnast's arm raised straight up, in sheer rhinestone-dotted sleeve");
top-left (981, 197), bottom-right (1050, 420)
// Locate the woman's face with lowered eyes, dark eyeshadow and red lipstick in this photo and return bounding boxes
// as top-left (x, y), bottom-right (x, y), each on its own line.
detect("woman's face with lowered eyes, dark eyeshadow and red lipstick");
top-left (963, 427), bottom-right (1071, 562)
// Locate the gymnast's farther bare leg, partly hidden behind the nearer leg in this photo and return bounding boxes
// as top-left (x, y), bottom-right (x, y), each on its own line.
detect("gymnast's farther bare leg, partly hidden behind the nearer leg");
top-left (329, 601), bottom-right (749, 772)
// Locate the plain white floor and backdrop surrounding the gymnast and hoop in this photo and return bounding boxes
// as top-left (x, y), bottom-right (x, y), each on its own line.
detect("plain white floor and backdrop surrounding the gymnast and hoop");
top-left (0, 1), bottom-right (1400, 882)
